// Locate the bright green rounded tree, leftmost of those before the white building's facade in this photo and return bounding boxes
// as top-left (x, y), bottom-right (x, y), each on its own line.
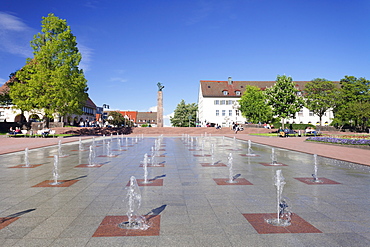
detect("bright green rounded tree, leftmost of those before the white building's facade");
top-left (239, 85), bottom-right (272, 123)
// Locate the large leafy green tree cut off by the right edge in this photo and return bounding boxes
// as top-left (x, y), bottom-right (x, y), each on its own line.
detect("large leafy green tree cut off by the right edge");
top-left (333, 76), bottom-right (370, 131)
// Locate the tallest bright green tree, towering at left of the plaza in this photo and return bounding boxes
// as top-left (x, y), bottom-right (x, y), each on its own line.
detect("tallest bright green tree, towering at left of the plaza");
top-left (10, 14), bottom-right (87, 124)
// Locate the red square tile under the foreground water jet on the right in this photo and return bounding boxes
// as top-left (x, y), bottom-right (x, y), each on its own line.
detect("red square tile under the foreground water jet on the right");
top-left (243, 213), bottom-right (322, 234)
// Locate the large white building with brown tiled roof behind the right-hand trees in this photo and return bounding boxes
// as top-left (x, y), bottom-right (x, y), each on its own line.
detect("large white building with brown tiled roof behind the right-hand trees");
top-left (198, 77), bottom-right (334, 127)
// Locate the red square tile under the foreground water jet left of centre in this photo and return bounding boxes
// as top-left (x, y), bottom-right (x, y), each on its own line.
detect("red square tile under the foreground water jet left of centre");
top-left (93, 215), bottom-right (161, 237)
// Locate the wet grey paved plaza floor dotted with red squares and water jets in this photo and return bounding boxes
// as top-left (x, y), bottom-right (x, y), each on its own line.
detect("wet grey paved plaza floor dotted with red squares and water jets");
top-left (0, 135), bottom-right (370, 246)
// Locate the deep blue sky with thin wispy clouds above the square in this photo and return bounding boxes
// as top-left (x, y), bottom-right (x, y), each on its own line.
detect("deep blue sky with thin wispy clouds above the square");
top-left (0, 0), bottom-right (370, 125)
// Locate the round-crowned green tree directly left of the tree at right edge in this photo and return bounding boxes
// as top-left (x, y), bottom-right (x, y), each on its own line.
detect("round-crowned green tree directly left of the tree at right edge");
top-left (304, 78), bottom-right (338, 125)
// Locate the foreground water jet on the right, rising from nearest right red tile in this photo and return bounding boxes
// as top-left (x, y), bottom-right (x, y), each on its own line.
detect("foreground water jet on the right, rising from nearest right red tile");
top-left (266, 170), bottom-right (291, 226)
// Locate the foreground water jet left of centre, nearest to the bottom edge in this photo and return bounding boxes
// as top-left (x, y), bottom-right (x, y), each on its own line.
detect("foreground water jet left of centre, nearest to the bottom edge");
top-left (118, 176), bottom-right (150, 230)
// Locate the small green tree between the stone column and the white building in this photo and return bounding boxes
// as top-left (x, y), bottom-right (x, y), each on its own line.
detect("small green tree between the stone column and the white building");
top-left (170, 100), bottom-right (198, 127)
